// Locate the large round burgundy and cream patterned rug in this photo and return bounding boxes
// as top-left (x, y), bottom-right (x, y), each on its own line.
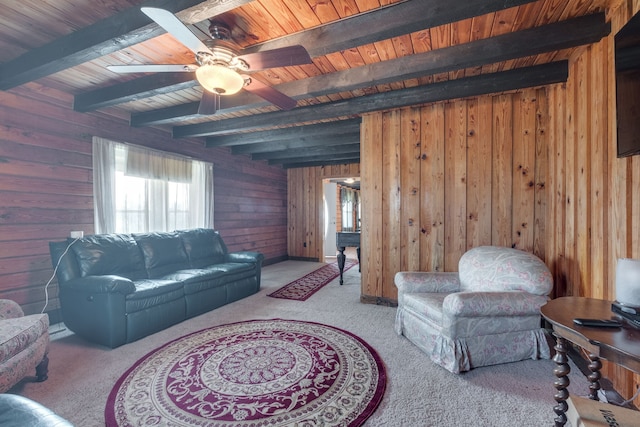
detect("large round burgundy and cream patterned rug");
top-left (105, 319), bottom-right (386, 427)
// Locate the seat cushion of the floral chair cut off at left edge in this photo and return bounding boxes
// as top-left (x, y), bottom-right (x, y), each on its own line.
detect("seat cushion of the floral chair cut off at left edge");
top-left (0, 314), bottom-right (49, 363)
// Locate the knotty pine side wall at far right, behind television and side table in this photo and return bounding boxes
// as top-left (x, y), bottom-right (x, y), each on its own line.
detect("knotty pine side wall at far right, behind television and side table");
top-left (545, 0), bottom-right (640, 405)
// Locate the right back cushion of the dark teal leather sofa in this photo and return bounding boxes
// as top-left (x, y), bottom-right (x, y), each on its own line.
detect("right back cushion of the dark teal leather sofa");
top-left (178, 228), bottom-right (227, 268)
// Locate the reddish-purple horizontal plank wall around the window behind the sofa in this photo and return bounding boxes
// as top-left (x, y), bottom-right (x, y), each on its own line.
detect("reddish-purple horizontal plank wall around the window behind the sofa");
top-left (0, 84), bottom-right (287, 321)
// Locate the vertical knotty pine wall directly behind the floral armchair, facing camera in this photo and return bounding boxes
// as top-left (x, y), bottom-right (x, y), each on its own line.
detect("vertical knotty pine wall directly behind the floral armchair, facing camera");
top-left (361, 89), bottom-right (548, 303)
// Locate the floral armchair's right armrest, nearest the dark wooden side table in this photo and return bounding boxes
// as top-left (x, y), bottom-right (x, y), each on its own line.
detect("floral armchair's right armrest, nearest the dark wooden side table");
top-left (442, 291), bottom-right (547, 317)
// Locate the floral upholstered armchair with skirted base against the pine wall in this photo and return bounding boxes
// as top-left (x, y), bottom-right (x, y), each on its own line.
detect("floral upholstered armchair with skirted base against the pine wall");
top-left (395, 246), bottom-right (553, 373)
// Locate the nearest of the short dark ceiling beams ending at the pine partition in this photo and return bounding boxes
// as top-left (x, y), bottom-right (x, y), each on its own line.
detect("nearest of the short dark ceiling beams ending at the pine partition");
top-left (206, 118), bottom-right (362, 148)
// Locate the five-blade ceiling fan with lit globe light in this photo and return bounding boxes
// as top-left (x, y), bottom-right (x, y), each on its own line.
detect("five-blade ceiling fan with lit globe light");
top-left (107, 7), bottom-right (311, 114)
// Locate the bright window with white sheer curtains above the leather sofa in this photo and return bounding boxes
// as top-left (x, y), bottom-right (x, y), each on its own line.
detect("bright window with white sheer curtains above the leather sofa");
top-left (93, 137), bottom-right (213, 233)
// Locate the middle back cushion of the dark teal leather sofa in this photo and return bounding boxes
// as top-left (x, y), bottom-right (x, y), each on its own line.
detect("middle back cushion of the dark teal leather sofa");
top-left (133, 232), bottom-right (189, 279)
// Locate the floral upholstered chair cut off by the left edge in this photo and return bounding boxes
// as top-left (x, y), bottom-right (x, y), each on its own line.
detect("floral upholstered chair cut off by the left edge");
top-left (0, 299), bottom-right (49, 393)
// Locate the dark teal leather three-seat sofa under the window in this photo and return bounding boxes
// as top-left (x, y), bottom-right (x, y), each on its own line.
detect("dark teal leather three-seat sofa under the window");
top-left (49, 228), bottom-right (264, 348)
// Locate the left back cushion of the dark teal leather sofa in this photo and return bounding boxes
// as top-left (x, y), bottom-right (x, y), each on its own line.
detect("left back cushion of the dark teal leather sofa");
top-left (71, 234), bottom-right (147, 280)
